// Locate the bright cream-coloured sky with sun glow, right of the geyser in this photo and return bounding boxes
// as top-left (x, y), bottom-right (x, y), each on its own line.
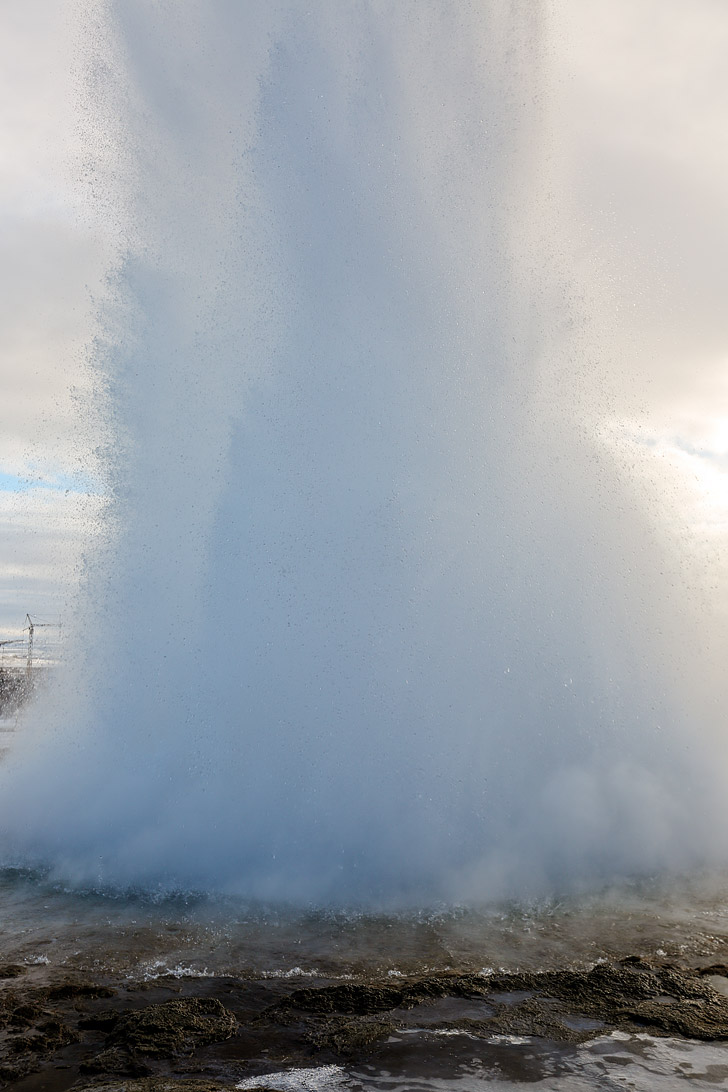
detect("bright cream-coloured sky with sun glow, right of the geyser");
top-left (557, 0), bottom-right (728, 613)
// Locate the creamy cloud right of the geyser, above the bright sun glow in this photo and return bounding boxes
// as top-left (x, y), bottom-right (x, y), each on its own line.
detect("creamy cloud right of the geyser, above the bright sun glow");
top-left (560, 0), bottom-right (728, 425)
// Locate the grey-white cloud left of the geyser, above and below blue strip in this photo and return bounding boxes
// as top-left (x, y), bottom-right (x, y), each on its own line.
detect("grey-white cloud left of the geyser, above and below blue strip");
top-left (0, 0), bottom-right (108, 638)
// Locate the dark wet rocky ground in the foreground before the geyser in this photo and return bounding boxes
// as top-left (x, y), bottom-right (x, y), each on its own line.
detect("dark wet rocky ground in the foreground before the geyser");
top-left (0, 956), bottom-right (728, 1092)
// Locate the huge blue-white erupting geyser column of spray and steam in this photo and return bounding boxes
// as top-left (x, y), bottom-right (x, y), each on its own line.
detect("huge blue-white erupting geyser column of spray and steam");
top-left (0, 0), bottom-right (725, 903)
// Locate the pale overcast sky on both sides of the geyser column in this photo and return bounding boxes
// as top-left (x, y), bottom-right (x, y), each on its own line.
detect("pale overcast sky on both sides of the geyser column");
top-left (0, 0), bottom-right (728, 638)
